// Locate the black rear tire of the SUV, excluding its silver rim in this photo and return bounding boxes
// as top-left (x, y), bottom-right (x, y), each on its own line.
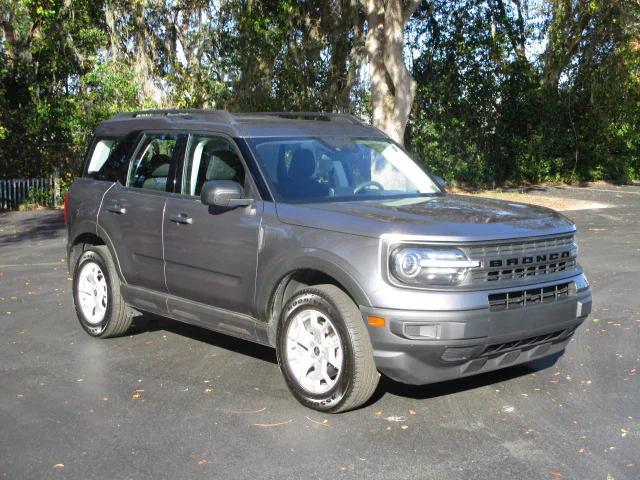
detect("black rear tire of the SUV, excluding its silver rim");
top-left (73, 245), bottom-right (133, 338)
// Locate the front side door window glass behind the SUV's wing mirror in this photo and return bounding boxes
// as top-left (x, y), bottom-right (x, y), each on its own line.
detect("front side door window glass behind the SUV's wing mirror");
top-left (182, 136), bottom-right (245, 195)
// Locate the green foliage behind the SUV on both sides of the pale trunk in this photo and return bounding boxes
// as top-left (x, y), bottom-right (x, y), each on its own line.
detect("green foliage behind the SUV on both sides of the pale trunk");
top-left (0, 0), bottom-right (640, 187)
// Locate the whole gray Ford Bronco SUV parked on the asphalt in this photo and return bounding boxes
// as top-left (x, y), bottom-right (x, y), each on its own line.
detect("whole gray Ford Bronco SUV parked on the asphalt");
top-left (65, 110), bottom-right (591, 412)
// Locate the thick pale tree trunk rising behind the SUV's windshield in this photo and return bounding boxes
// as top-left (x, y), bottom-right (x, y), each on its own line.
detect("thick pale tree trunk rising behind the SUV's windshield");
top-left (362, 0), bottom-right (420, 143)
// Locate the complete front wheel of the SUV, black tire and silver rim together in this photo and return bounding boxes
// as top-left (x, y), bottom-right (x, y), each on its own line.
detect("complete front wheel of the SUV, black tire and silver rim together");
top-left (276, 285), bottom-right (380, 413)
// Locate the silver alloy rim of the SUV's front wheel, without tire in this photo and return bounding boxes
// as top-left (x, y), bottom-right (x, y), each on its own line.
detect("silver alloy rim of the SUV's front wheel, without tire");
top-left (286, 309), bottom-right (343, 395)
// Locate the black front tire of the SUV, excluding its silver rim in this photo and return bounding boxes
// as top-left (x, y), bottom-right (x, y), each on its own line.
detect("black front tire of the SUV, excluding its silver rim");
top-left (276, 285), bottom-right (380, 413)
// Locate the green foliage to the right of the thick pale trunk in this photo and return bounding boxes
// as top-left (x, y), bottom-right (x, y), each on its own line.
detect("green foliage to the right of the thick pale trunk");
top-left (407, 0), bottom-right (640, 186)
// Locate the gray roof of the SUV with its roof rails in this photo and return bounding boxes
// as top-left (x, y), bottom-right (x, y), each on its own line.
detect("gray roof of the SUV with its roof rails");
top-left (95, 110), bottom-right (386, 137)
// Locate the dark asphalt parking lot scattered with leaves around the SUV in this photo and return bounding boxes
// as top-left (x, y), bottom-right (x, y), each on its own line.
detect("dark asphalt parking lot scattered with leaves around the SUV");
top-left (0, 185), bottom-right (640, 480)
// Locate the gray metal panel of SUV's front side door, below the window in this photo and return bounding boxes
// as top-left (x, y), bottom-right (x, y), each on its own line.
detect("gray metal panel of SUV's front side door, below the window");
top-left (163, 195), bottom-right (263, 315)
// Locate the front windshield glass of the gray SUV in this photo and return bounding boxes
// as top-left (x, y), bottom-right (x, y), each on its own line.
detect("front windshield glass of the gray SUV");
top-left (249, 137), bottom-right (441, 202)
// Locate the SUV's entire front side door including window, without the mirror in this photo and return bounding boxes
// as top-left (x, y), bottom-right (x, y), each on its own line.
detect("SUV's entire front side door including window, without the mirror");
top-left (164, 135), bottom-right (262, 314)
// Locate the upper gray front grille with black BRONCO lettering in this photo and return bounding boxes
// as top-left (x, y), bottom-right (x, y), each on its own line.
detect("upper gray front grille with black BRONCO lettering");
top-left (466, 235), bottom-right (577, 284)
